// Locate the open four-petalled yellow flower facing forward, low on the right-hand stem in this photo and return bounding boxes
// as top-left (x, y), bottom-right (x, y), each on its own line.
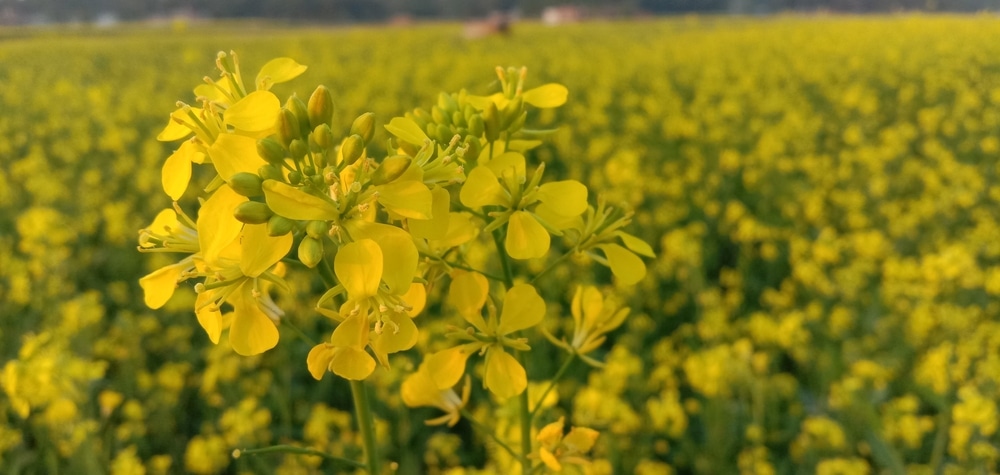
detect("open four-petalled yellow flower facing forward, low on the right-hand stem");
top-left (424, 271), bottom-right (545, 399)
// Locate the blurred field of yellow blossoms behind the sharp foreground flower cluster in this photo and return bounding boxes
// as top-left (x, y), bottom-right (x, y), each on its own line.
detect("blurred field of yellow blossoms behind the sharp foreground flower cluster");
top-left (0, 15), bottom-right (1000, 474)
